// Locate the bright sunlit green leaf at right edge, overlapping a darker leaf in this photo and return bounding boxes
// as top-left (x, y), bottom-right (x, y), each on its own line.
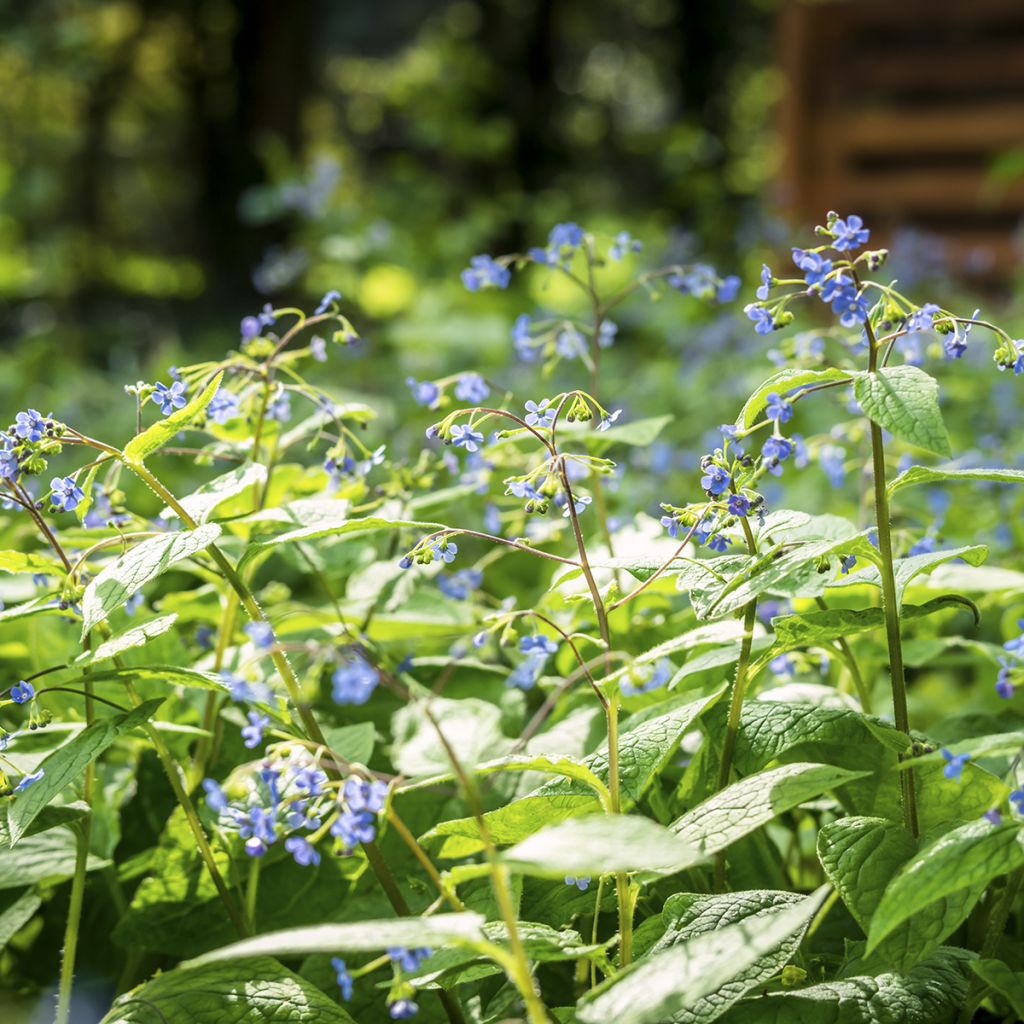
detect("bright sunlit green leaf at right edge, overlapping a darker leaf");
top-left (867, 820), bottom-right (1024, 952)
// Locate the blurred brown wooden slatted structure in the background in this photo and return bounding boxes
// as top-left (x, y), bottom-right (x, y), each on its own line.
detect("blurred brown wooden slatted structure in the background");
top-left (779, 0), bottom-right (1024, 276)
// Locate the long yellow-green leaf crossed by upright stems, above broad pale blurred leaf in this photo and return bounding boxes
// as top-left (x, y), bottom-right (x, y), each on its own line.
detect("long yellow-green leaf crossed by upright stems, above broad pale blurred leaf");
top-left (423, 690), bottom-right (723, 858)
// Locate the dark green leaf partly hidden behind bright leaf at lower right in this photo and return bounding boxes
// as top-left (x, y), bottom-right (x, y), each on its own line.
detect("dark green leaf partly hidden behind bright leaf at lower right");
top-left (818, 817), bottom-right (984, 973)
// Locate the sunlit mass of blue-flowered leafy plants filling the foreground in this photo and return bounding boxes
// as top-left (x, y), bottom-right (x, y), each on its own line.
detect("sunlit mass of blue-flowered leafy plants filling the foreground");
top-left (0, 213), bottom-right (1024, 1024)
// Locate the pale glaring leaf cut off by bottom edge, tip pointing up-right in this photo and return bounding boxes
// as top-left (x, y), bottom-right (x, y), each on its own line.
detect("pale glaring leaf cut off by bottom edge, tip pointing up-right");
top-left (577, 887), bottom-right (828, 1024)
